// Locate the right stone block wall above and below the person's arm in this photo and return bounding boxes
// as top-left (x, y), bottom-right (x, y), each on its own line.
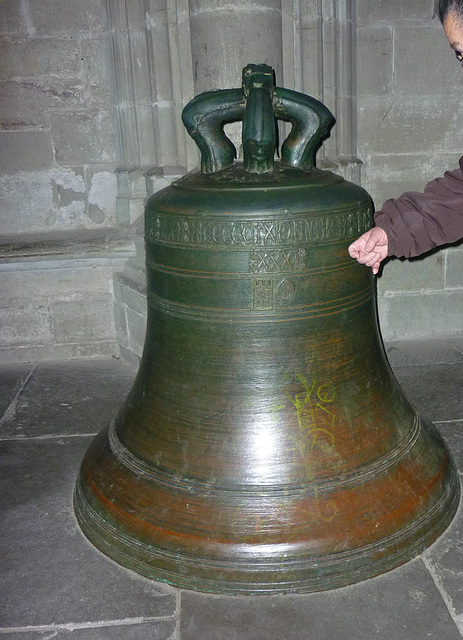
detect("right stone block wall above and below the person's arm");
top-left (357, 0), bottom-right (463, 340)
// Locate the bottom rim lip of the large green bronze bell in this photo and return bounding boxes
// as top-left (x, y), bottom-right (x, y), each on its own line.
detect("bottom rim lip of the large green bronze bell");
top-left (73, 461), bottom-right (461, 595)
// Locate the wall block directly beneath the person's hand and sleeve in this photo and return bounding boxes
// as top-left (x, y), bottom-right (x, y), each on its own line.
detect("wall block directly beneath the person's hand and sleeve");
top-left (378, 251), bottom-right (445, 295)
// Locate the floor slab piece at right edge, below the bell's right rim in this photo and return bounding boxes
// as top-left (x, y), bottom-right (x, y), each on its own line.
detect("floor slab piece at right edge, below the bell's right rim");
top-left (424, 492), bottom-right (463, 617)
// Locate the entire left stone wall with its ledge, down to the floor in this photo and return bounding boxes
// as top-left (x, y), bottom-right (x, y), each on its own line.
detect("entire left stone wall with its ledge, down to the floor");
top-left (0, 0), bottom-right (132, 361)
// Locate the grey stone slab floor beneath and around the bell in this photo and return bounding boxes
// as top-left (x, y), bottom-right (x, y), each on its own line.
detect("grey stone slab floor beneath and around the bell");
top-left (0, 340), bottom-right (463, 640)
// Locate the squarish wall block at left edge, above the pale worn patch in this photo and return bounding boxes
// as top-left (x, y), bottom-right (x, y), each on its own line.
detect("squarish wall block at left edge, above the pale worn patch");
top-left (0, 131), bottom-right (53, 174)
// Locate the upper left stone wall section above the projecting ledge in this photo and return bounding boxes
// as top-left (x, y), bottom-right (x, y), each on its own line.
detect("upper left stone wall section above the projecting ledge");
top-left (0, 0), bottom-right (116, 235)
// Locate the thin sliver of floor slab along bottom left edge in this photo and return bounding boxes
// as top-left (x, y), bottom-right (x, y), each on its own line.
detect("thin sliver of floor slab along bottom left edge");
top-left (0, 620), bottom-right (177, 640)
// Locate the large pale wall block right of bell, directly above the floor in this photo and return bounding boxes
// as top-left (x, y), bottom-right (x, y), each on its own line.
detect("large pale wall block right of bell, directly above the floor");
top-left (379, 290), bottom-right (463, 340)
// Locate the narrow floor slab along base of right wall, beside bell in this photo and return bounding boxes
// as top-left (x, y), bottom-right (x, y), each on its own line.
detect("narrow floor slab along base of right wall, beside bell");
top-left (384, 340), bottom-right (463, 368)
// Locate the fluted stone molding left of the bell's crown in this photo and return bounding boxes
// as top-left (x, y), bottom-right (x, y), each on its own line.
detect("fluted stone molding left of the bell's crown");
top-left (106, 0), bottom-right (196, 224)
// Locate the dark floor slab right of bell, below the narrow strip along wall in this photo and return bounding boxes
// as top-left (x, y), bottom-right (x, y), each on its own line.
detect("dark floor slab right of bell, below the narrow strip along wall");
top-left (394, 363), bottom-right (463, 421)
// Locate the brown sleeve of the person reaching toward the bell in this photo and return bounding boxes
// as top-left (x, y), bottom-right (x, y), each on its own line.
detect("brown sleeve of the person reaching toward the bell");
top-left (374, 157), bottom-right (463, 258)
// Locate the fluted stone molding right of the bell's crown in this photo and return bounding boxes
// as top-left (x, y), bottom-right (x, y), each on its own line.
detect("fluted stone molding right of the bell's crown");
top-left (283, 0), bottom-right (362, 184)
